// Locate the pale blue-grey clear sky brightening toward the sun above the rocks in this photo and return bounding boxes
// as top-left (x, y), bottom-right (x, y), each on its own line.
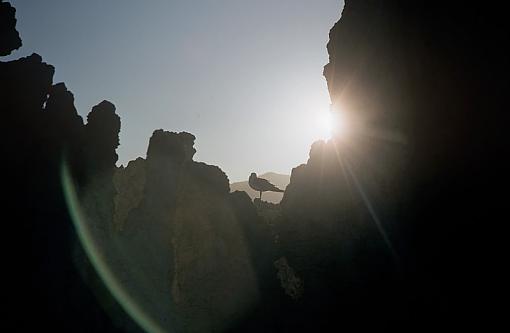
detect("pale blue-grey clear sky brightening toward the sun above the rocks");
top-left (3, 0), bottom-right (343, 182)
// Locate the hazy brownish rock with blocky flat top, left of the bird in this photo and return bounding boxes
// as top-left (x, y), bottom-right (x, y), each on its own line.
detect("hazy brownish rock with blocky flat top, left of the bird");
top-left (106, 130), bottom-right (276, 332)
